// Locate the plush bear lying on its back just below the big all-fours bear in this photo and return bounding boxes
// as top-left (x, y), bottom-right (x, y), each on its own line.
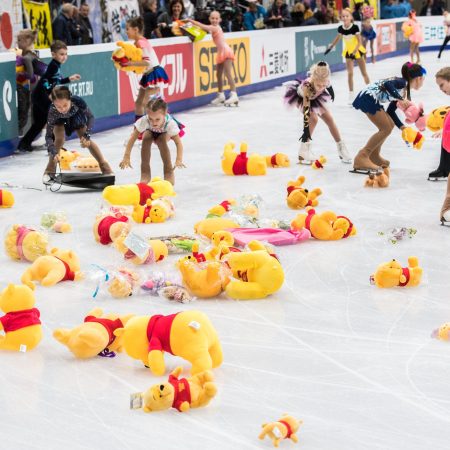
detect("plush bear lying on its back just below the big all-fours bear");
top-left (142, 367), bottom-right (217, 412)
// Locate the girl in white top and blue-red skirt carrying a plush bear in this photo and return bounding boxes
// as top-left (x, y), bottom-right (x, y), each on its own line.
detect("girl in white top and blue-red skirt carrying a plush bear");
top-left (125, 17), bottom-right (169, 121)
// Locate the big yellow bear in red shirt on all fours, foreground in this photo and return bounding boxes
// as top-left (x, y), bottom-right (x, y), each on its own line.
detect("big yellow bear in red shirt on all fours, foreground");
top-left (114, 311), bottom-right (223, 376)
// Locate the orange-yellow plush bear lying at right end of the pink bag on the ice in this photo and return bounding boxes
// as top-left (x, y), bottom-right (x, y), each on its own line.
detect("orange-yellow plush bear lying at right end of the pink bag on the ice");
top-left (291, 207), bottom-right (356, 241)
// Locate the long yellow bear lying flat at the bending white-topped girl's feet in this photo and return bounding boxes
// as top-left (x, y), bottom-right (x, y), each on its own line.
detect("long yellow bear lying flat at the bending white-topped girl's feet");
top-left (102, 177), bottom-right (176, 206)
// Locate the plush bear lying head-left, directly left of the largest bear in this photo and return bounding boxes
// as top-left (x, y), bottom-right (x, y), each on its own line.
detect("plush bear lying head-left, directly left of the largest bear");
top-left (53, 308), bottom-right (133, 358)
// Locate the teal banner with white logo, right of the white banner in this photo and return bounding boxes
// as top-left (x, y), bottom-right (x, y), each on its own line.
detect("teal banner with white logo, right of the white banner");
top-left (295, 27), bottom-right (343, 73)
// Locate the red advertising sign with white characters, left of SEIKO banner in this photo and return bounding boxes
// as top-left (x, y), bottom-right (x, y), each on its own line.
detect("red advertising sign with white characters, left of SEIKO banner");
top-left (119, 44), bottom-right (194, 114)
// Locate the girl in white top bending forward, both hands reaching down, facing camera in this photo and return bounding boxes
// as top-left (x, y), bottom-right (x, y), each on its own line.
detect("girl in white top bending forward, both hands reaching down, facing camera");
top-left (119, 98), bottom-right (185, 184)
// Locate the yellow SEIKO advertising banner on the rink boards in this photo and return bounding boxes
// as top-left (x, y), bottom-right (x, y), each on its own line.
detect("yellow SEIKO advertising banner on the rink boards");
top-left (193, 37), bottom-right (250, 96)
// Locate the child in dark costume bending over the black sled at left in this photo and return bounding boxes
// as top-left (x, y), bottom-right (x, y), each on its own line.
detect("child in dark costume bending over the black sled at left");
top-left (43, 86), bottom-right (113, 184)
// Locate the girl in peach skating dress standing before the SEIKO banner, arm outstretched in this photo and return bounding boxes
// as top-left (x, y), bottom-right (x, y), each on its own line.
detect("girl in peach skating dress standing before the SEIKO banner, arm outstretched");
top-left (186, 11), bottom-right (239, 106)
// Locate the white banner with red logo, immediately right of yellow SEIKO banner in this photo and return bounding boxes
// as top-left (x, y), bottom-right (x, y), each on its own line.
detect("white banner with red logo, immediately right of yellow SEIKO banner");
top-left (250, 30), bottom-right (296, 83)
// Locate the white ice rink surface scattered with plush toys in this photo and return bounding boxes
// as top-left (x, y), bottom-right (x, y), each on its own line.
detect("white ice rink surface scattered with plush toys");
top-left (0, 53), bottom-right (450, 450)
